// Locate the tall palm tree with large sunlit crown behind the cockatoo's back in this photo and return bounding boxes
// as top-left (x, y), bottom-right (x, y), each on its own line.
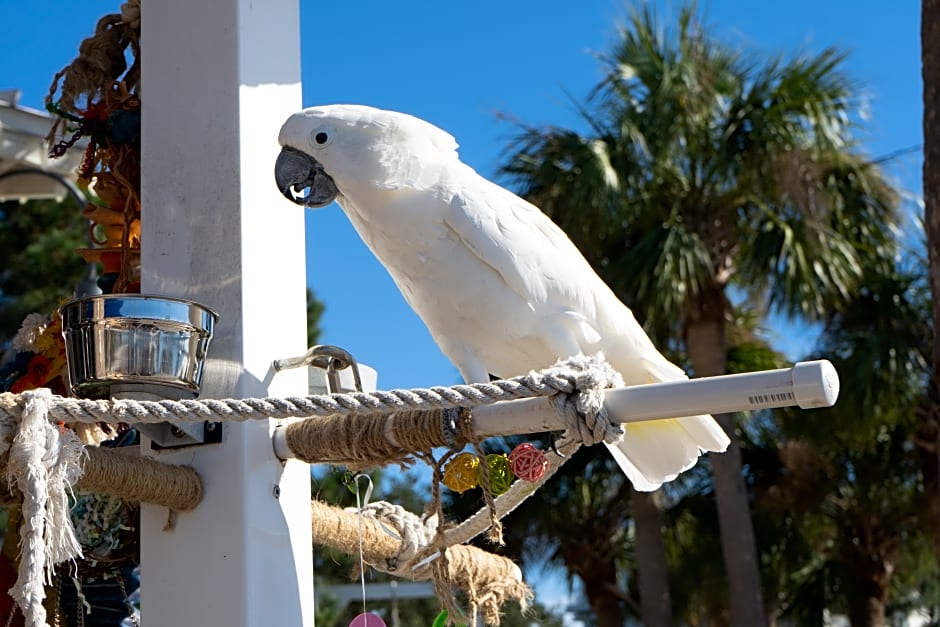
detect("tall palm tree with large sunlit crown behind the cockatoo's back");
top-left (504, 5), bottom-right (895, 626)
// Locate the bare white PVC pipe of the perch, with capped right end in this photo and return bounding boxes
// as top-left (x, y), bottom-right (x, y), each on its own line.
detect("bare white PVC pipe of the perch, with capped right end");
top-left (273, 360), bottom-right (839, 459)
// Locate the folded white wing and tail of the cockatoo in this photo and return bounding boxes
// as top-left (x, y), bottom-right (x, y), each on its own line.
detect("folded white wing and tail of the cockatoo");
top-left (444, 173), bottom-right (729, 491)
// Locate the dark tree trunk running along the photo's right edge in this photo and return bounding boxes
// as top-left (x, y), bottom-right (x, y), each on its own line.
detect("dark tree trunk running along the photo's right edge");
top-left (920, 0), bottom-right (940, 559)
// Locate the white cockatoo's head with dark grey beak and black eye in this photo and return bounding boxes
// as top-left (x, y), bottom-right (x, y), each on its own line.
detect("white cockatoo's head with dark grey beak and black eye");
top-left (274, 105), bottom-right (457, 208)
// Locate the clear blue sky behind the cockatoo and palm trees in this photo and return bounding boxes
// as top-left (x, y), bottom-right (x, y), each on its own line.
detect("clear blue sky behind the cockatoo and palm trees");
top-left (0, 0), bottom-right (921, 388)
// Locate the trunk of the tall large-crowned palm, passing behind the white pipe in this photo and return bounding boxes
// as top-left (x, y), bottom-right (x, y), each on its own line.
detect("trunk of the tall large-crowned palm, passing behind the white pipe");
top-left (686, 287), bottom-right (767, 627)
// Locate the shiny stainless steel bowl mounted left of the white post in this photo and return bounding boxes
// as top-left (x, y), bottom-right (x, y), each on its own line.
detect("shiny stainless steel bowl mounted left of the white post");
top-left (59, 294), bottom-right (219, 398)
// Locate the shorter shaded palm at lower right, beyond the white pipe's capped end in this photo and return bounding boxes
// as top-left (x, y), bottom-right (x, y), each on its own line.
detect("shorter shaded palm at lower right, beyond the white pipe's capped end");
top-left (756, 254), bottom-right (938, 627)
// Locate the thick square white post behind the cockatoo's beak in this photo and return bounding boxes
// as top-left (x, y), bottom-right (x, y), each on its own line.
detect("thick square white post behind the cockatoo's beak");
top-left (141, 0), bottom-right (313, 627)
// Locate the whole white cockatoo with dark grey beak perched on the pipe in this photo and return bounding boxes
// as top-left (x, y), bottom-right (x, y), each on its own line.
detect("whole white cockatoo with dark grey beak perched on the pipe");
top-left (275, 105), bottom-right (729, 491)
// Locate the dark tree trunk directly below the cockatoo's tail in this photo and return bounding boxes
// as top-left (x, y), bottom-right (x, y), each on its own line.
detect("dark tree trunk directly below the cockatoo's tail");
top-left (630, 490), bottom-right (672, 627)
